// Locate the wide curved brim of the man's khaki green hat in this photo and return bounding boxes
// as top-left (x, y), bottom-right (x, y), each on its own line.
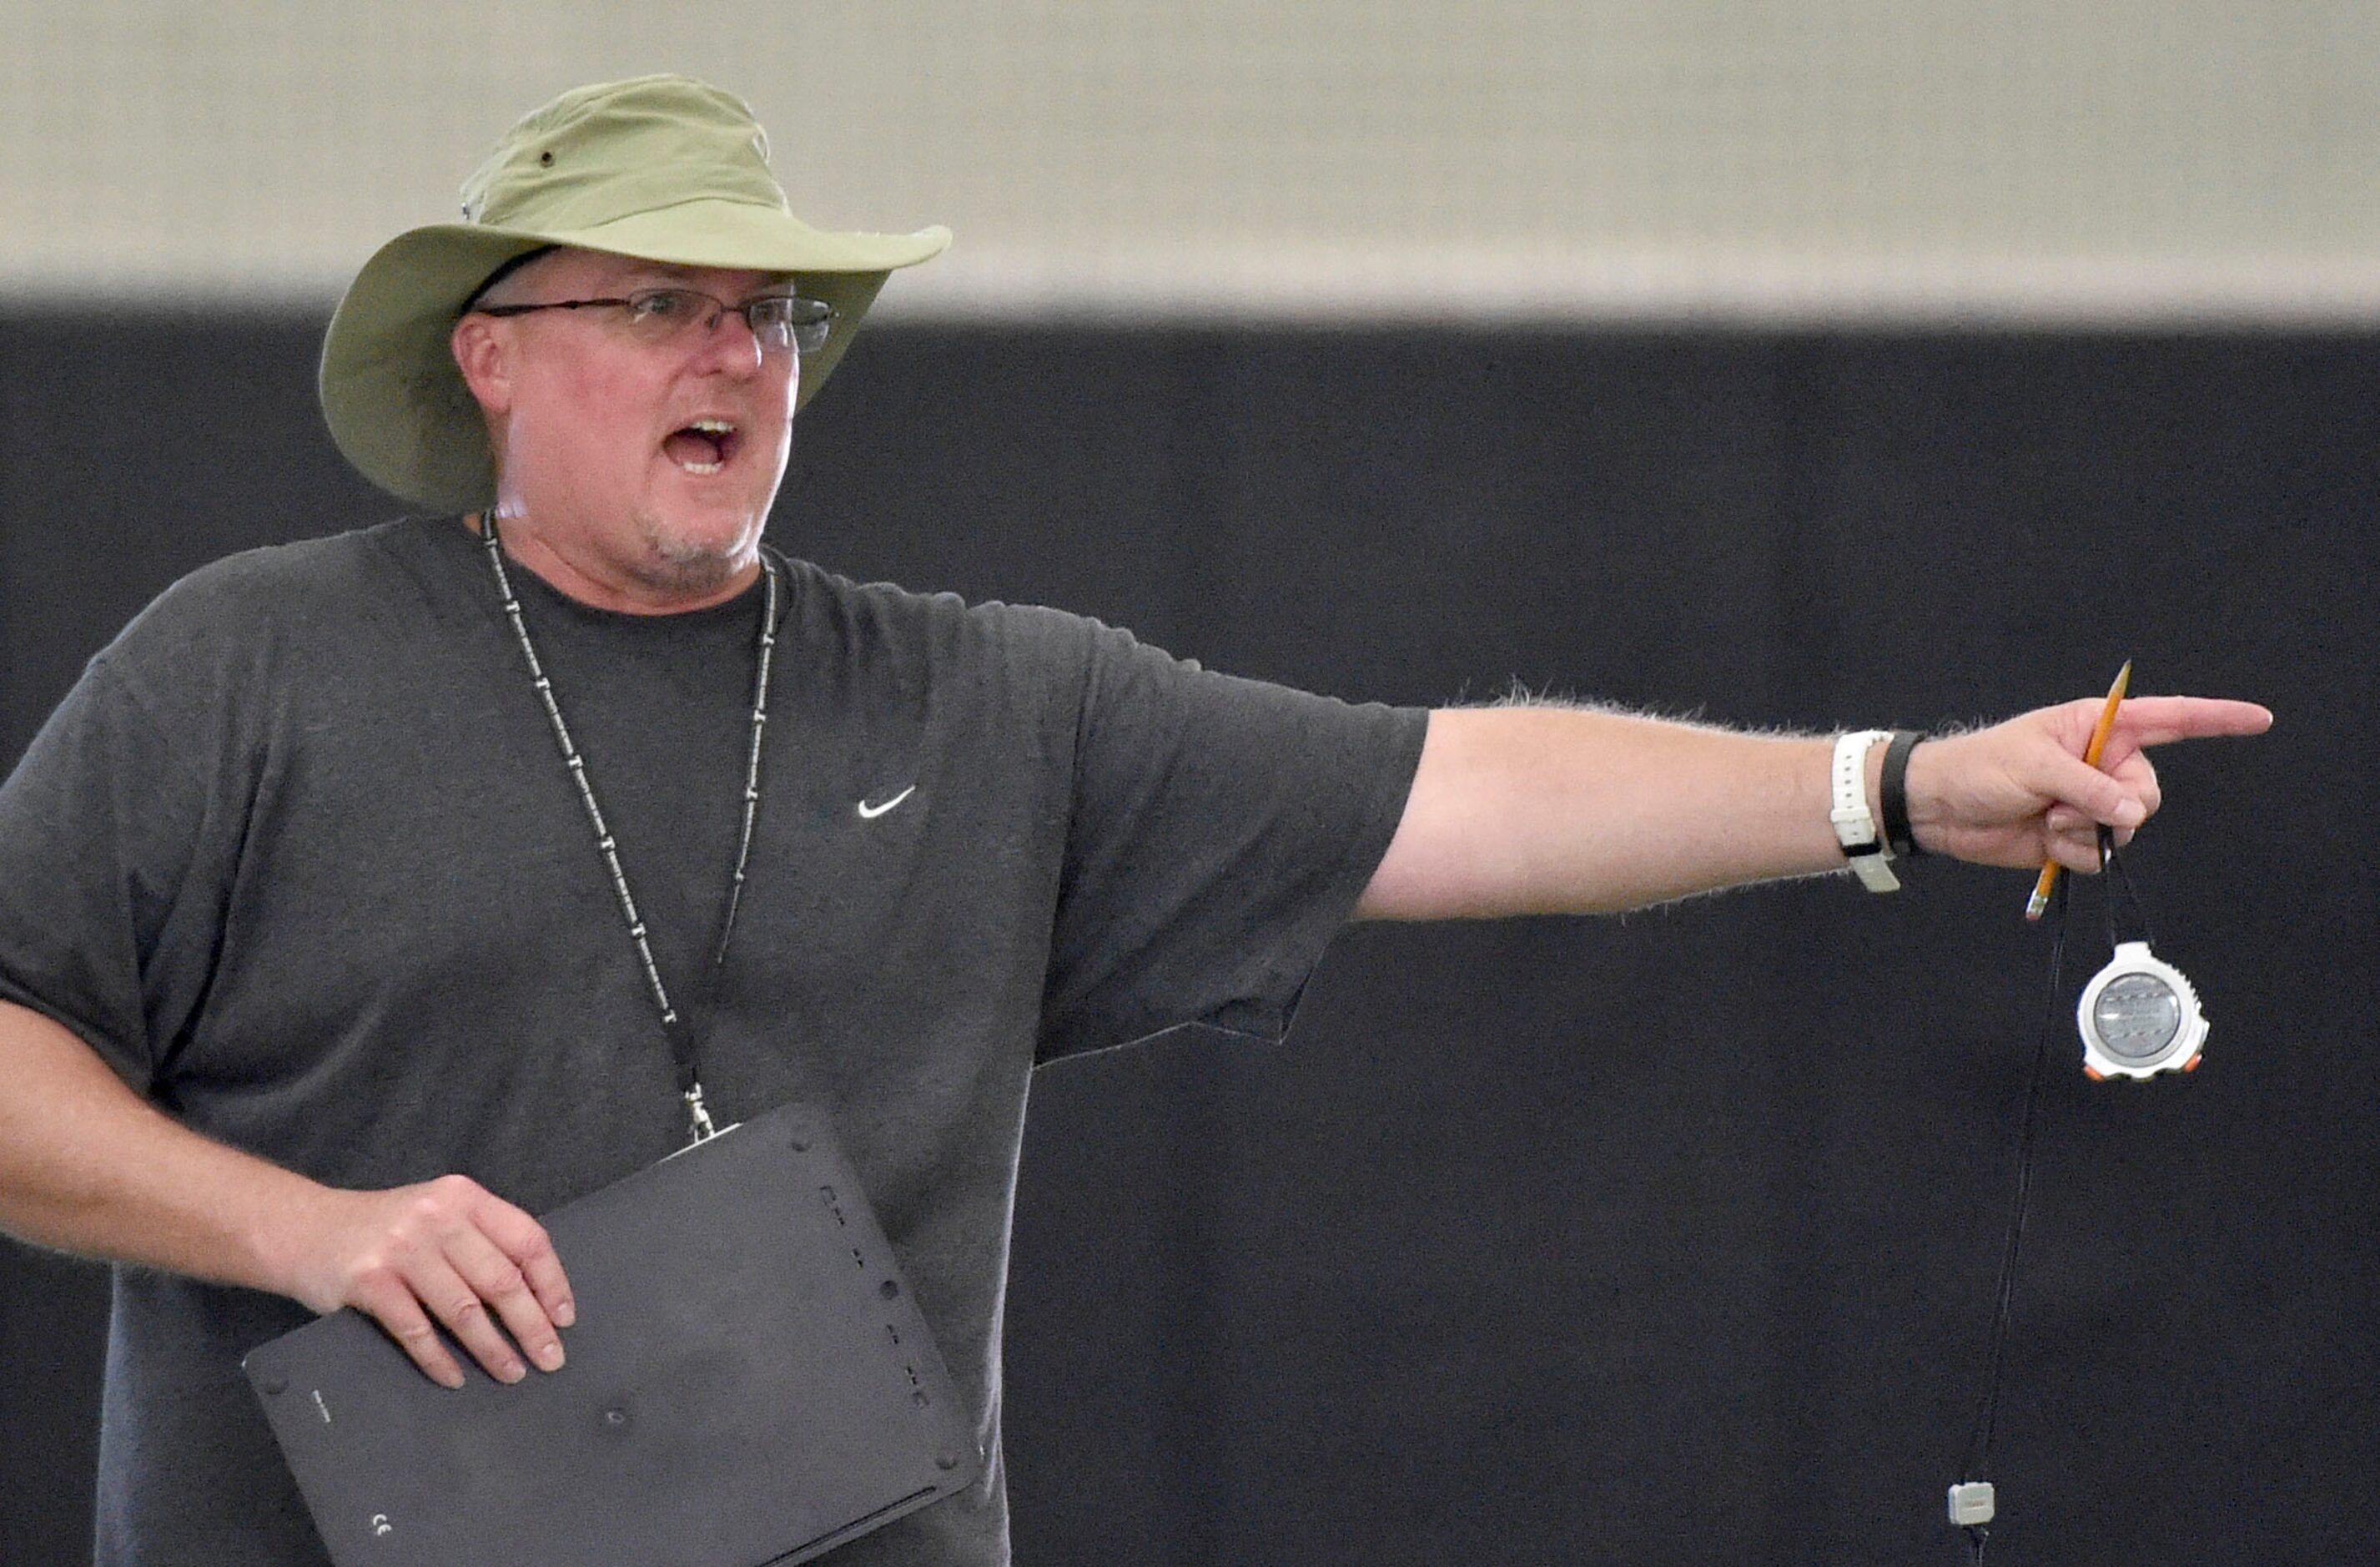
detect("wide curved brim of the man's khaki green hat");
top-left (319, 198), bottom-right (949, 512)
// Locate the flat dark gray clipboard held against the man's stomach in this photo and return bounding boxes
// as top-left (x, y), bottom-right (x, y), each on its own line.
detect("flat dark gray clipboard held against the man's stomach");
top-left (240, 1105), bottom-right (983, 1567)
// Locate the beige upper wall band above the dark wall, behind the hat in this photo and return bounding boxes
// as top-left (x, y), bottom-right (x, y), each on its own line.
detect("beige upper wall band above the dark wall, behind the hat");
top-left (0, 0), bottom-right (2380, 319)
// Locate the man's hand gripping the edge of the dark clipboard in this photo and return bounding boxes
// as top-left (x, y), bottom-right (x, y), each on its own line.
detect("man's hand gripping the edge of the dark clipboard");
top-left (284, 1177), bottom-right (576, 1388)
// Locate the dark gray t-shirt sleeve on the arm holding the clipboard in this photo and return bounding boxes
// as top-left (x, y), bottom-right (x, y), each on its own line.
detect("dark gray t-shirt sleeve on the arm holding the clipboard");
top-left (0, 655), bottom-right (221, 1091)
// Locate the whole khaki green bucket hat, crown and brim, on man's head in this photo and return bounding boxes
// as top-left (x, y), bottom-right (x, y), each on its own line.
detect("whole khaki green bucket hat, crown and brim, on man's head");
top-left (321, 76), bottom-right (949, 512)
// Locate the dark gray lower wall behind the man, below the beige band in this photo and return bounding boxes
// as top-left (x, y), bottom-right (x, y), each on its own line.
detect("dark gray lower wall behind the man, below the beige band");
top-left (0, 315), bottom-right (2380, 1567)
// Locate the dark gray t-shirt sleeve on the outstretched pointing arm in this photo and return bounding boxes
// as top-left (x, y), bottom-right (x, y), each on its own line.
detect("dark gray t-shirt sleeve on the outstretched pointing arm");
top-left (1040, 627), bottom-right (1428, 1060)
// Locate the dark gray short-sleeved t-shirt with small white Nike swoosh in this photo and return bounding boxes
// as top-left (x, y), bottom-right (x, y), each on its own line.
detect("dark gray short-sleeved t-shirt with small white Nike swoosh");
top-left (0, 519), bottom-right (1426, 1567)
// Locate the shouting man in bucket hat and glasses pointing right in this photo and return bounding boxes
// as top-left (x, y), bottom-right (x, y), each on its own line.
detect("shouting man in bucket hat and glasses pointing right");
top-left (0, 78), bottom-right (2268, 1564)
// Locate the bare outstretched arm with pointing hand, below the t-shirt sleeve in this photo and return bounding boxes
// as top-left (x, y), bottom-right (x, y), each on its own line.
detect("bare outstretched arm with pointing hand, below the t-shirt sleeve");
top-left (1356, 695), bottom-right (2273, 920)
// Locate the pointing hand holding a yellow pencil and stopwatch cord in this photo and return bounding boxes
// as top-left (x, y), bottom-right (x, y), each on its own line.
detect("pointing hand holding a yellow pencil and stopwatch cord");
top-left (1870, 695), bottom-right (2273, 872)
